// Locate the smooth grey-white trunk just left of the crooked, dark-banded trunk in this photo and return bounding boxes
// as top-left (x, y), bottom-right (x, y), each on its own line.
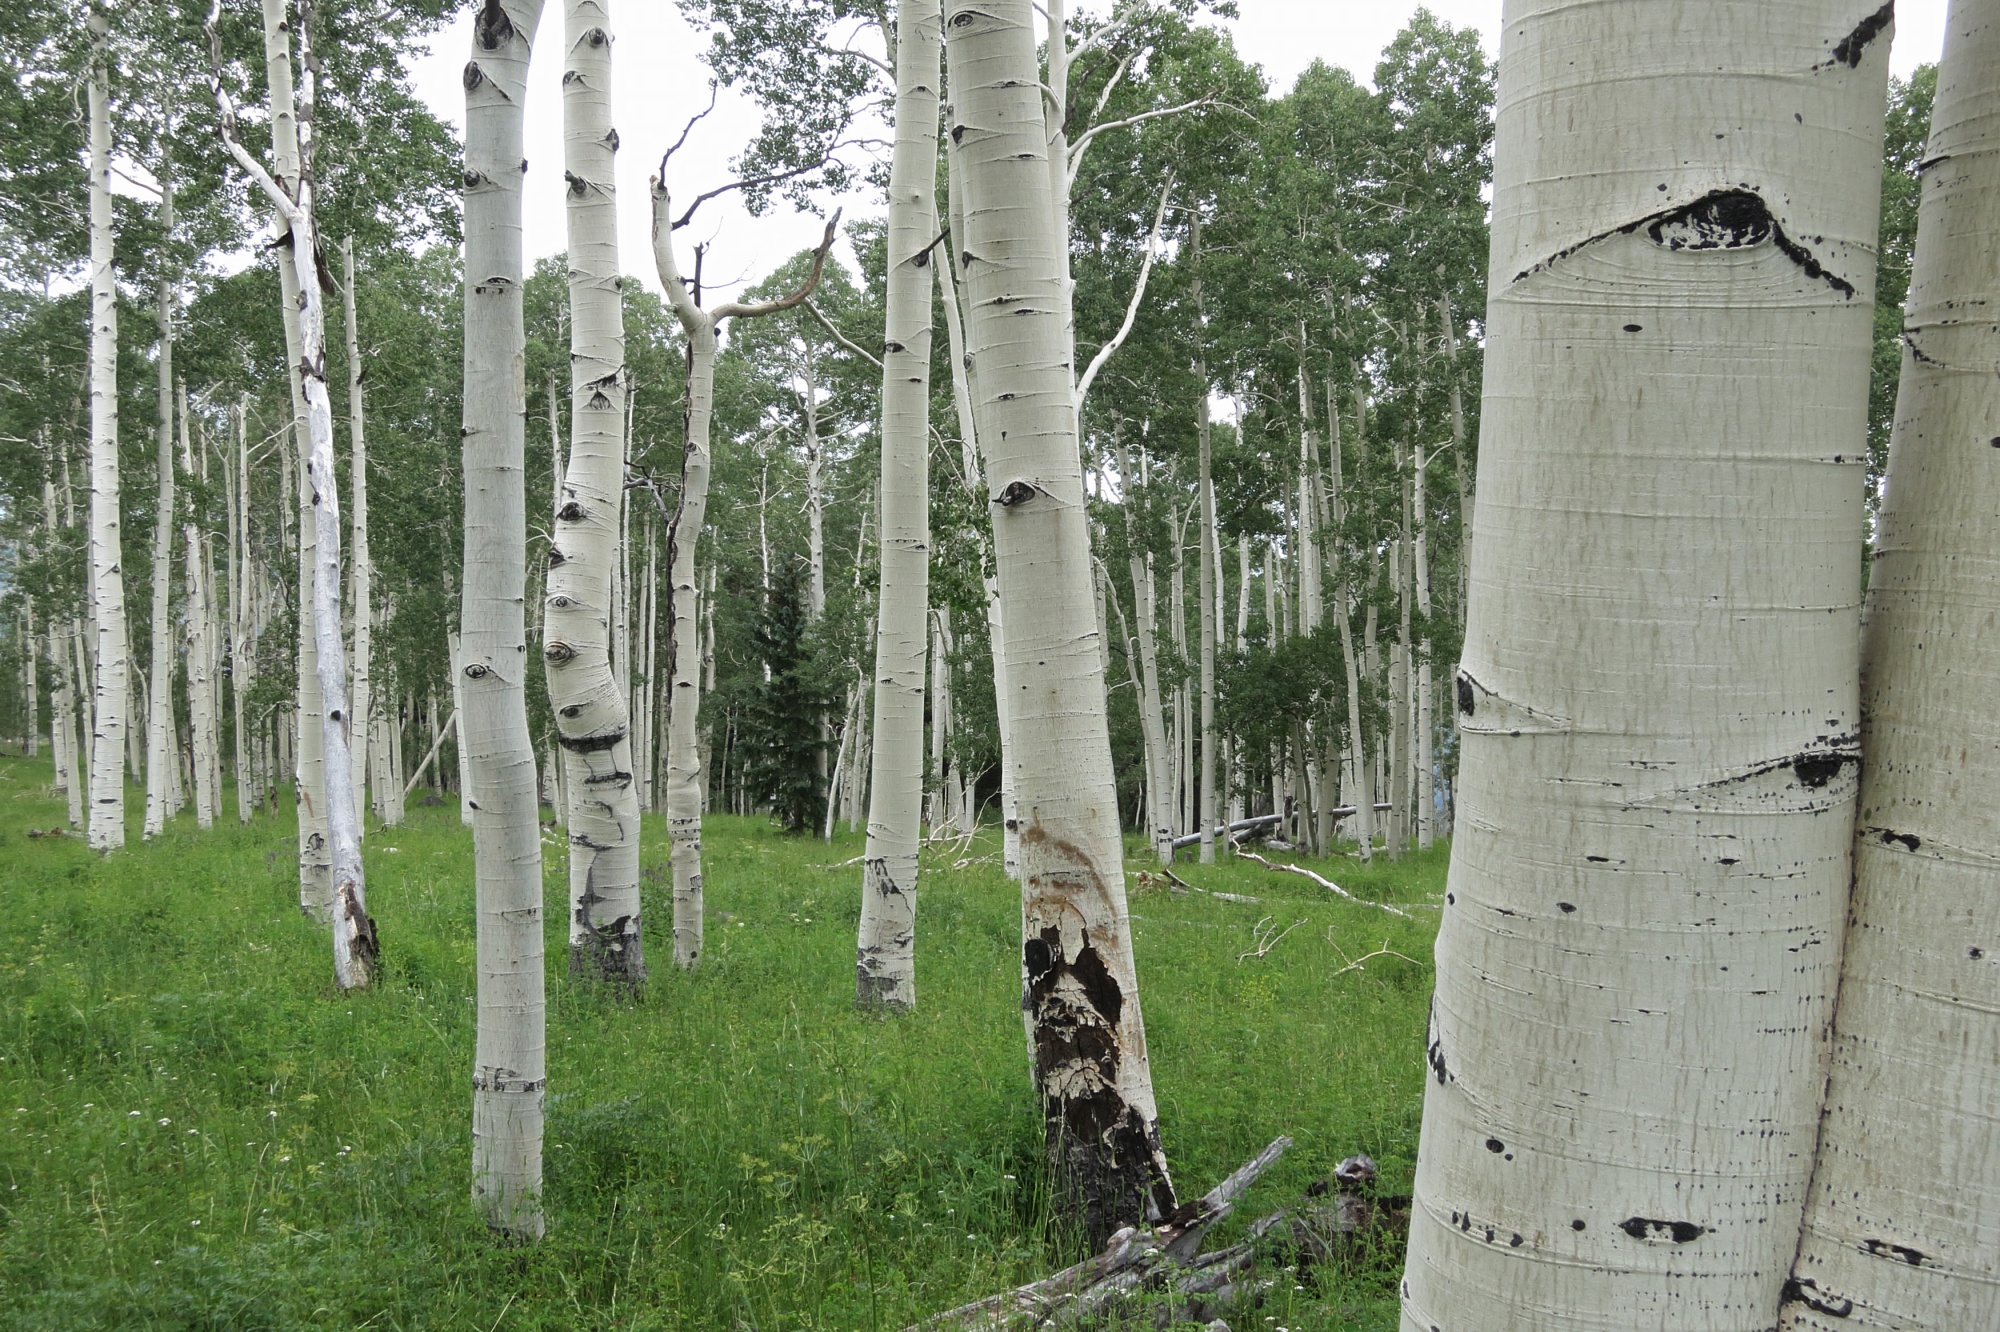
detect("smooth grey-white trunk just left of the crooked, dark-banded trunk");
top-left (458, 0), bottom-right (544, 1240)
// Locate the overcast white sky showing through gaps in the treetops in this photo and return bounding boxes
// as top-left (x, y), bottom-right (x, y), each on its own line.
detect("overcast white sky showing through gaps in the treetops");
top-left (398, 0), bottom-right (1946, 290)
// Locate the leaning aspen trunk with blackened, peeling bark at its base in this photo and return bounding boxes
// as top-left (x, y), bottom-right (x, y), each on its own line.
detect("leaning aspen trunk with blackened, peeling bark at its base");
top-left (944, 0), bottom-right (1174, 1244)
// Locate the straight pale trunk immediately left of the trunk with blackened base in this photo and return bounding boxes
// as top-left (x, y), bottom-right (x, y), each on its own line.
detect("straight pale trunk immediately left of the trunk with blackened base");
top-left (854, 0), bottom-right (942, 1008)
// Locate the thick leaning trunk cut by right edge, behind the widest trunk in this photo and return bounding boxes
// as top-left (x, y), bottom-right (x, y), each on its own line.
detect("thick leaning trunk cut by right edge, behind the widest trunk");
top-left (1792, 0), bottom-right (2000, 1332)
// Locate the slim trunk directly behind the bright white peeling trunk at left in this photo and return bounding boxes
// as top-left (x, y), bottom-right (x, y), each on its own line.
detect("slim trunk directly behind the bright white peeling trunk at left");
top-left (264, 0), bottom-right (334, 908)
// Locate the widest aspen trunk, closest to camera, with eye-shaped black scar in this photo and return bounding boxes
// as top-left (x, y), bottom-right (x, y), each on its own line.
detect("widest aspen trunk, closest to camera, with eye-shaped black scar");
top-left (1402, 0), bottom-right (1888, 1332)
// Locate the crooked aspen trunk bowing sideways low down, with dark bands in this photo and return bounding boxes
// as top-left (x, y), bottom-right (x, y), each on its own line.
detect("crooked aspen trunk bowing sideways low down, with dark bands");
top-left (542, 0), bottom-right (646, 986)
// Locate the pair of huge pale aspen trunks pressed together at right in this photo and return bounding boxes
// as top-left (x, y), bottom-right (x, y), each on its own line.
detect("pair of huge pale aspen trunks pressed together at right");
top-left (1402, 0), bottom-right (2000, 1332)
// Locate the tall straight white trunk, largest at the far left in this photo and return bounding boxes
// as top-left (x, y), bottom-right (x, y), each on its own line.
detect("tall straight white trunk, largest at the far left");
top-left (78, 2), bottom-right (132, 850)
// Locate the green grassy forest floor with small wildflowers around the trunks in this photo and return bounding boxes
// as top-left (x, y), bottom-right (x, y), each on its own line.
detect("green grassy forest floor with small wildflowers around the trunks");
top-left (0, 758), bottom-right (1444, 1332)
